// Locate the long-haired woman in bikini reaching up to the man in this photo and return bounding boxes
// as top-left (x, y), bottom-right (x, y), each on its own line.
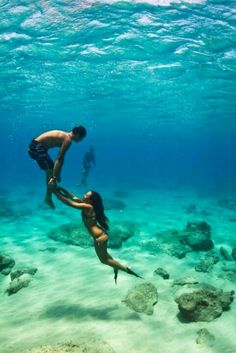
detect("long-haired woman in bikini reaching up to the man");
top-left (53, 187), bottom-right (142, 282)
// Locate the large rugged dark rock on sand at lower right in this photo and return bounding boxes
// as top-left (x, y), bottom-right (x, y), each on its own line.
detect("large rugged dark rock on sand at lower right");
top-left (175, 286), bottom-right (234, 321)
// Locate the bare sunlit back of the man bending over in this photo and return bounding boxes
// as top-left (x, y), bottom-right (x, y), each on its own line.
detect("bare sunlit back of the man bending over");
top-left (35, 130), bottom-right (72, 149)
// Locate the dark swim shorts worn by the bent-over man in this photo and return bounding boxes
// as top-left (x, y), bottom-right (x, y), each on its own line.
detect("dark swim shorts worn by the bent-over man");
top-left (28, 140), bottom-right (54, 170)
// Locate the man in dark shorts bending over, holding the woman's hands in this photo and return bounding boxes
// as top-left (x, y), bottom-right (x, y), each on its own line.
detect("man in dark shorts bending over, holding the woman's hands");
top-left (28, 125), bottom-right (87, 209)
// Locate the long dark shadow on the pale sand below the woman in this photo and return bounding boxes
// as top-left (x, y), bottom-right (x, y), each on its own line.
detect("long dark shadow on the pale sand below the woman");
top-left (39, 304), bottom-right (140, 321)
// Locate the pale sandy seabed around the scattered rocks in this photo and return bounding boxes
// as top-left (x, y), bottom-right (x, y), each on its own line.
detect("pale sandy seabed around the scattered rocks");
top-left (0, 184), bottom-right (236, 353)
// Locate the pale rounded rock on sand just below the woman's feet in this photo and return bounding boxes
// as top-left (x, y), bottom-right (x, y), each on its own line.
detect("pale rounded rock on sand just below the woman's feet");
top-left (123, 282), bottom-right (158, 315)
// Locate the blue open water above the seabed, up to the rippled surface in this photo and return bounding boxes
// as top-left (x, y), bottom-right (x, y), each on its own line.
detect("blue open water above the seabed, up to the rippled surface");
top-left (0, 0), bottom-right (236, 188)
